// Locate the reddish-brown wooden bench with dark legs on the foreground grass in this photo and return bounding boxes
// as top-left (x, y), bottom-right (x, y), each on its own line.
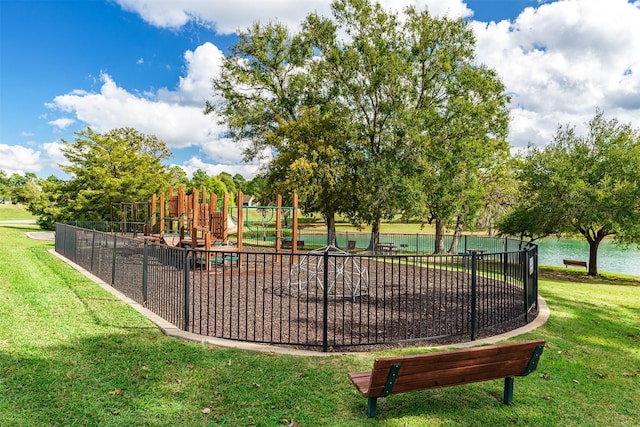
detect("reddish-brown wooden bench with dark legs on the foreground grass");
top-left (349, 340), bottom-right (545, 418)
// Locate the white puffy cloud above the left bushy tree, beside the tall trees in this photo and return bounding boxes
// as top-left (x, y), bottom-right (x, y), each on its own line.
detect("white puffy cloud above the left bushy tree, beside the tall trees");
top-left (48, 42), bottom-right (248, 173)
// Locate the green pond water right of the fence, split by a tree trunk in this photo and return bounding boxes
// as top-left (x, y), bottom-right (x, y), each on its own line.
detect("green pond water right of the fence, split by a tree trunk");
top-left (536, 238), bottom-right (640, 276)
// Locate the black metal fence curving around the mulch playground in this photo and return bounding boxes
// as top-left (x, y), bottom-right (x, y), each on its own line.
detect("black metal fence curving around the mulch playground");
top-left (55, 224), bottom-right (538, 351)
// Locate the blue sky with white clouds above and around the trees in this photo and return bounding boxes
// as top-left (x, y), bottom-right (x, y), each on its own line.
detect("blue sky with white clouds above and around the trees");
top-left (0, 0), bottom-right (640, 177)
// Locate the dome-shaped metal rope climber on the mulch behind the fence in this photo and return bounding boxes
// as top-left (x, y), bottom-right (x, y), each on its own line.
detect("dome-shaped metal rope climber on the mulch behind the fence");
top-left (287, 245), bottom-right (369, 301)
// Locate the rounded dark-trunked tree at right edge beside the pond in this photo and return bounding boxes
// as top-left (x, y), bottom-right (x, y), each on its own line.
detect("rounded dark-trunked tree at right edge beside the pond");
top-left (501, 111), bottom-right (640, 275)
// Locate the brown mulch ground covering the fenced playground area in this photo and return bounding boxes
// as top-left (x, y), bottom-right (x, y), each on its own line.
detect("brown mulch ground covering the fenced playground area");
top-left (78, 242), bottom-right (537, 351)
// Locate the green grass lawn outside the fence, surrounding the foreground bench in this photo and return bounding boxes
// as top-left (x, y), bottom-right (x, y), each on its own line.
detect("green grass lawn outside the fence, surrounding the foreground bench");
top-left (0, 225), bottom-right (640, 426)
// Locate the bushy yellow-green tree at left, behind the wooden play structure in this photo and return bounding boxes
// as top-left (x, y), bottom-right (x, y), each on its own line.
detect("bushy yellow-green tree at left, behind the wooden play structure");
top-left (34, 128), bottom-right (171, 221)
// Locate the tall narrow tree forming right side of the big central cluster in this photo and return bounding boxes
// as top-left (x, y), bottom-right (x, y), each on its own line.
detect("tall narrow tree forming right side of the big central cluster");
top-left (400, 8), bottom-right (509, 252)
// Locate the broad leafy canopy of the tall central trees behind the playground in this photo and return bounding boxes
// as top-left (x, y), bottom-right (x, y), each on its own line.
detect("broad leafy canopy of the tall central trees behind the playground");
top-left (205, 0), bottom-right (508, 247)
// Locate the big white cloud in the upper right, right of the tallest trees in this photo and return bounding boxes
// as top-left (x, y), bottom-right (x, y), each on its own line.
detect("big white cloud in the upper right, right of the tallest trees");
top-left (474, 0), bottom-right (640, 147)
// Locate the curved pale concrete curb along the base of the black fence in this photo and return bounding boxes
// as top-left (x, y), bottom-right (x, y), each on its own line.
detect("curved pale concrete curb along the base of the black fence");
top-left (49, 249), bottom-right (550, 357)
